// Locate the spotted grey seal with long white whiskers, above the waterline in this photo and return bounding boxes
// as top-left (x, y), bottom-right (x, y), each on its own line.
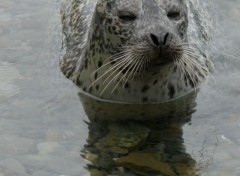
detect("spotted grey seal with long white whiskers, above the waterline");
top-left (60, 0), bottom-right (213, 103)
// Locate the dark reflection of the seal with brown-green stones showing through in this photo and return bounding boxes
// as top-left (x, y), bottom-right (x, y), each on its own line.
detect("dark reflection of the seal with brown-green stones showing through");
top-left (79, 93), bottom-right (201, 176)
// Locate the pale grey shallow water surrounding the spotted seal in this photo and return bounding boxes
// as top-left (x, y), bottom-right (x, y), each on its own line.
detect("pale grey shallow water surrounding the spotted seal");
top-left (0, 0), bottom-right (240, 176)
